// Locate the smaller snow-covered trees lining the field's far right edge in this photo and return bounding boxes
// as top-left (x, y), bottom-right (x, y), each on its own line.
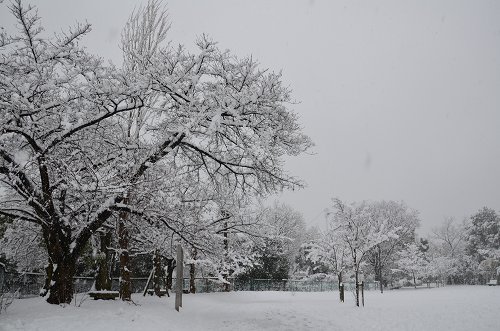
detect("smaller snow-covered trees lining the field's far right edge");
top-left (302, 199), bottom-right (500, 306)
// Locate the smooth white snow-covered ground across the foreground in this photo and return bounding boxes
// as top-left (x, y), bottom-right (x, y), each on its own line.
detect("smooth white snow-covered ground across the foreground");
top-left (0, 286), bottom-right (500, 331)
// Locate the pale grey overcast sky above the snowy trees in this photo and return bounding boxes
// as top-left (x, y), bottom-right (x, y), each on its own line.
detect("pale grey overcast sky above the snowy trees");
top-left (0, 0), bottom-right (500, 233)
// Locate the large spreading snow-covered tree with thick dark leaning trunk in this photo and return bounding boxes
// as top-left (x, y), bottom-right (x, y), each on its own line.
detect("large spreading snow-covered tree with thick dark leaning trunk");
top-left (0, 0), bottom-right (312, 303)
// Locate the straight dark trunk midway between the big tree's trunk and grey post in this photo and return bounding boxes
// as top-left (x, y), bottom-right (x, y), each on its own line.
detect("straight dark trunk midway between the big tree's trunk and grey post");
top-left (118, 212), bottom-right (132, 301)
